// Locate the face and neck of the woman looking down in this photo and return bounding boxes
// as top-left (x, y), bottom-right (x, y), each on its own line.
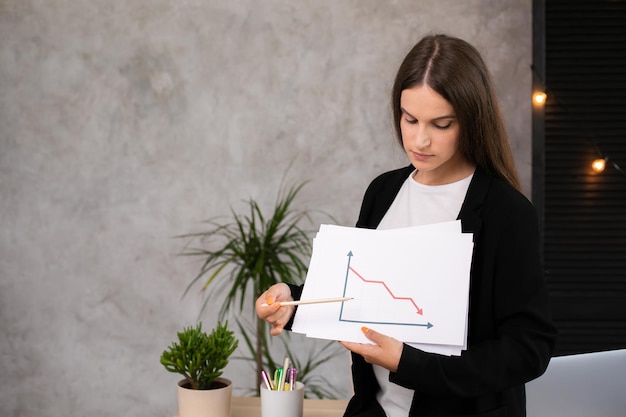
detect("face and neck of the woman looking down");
top-left (400, 85), bottom-right (473, 185)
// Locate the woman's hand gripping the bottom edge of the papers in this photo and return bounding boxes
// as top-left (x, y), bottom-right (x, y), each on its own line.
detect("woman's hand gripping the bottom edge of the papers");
top-left (339, 327), bottom-right (403, 372)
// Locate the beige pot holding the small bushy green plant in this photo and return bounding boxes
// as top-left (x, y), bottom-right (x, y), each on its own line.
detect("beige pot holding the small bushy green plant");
top-left (178, 378), bottom-right (233, 417)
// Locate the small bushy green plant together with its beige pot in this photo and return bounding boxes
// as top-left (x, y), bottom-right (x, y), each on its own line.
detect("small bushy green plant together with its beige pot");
top-left (161, 322), bottom-right (239, 417)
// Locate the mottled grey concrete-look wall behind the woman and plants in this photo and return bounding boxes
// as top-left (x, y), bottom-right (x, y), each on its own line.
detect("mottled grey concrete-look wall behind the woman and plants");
top-left (0, 0), bottom-right (531, 417)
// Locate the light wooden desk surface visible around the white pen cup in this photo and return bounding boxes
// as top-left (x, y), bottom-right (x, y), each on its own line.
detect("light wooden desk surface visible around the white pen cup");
top-left (230, 397), bottom-right (348, 417)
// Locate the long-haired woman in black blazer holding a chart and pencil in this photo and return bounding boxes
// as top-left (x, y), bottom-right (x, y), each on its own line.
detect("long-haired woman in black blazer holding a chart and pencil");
top-left (256, 35), bottom-right (556, 417)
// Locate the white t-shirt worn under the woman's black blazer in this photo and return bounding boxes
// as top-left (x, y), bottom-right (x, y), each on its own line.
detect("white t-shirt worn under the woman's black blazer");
top-left (373, 171), bottom-right (473, 417)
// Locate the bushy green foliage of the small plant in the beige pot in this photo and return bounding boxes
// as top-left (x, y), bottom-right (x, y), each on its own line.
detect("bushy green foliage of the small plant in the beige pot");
top-left (161, 321), bottom-right (239, 390)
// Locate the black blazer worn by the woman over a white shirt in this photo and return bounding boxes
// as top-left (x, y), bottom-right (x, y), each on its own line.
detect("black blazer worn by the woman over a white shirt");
top-left (342, 166), bottom-right (556, 417)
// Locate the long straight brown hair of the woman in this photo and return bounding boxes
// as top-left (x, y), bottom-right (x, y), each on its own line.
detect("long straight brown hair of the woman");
top-left (392, 35), bottom-right (521, 191)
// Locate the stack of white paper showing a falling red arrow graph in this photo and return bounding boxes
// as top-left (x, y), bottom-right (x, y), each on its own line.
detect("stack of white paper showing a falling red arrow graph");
top-left (292, 221), bottom-right (473, 355)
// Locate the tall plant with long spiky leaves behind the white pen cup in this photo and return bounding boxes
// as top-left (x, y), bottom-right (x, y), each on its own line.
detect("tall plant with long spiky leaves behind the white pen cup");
top-left (179, 183), bottom-right (342, 397)
